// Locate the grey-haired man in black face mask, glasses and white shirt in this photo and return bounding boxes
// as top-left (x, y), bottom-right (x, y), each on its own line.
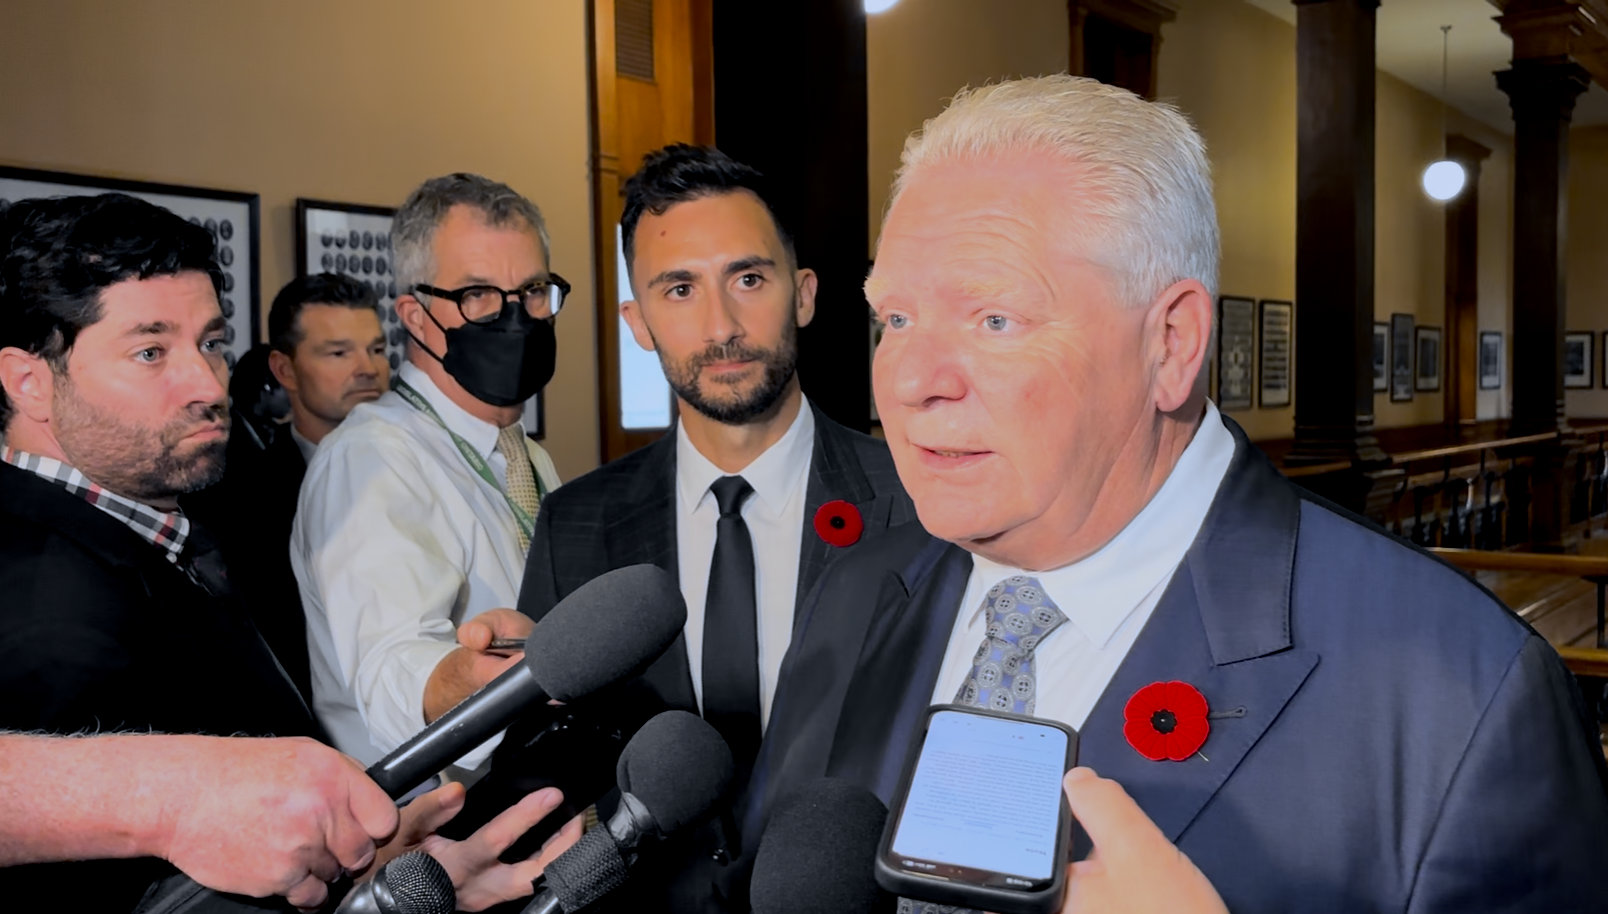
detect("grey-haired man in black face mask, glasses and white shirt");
top-left (291, 174), bottom-right (569, 771)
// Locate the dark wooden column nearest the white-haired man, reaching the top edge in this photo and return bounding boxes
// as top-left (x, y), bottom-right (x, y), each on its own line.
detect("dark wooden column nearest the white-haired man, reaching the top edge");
top-left (1286, 0), bottom-right (1384, 469)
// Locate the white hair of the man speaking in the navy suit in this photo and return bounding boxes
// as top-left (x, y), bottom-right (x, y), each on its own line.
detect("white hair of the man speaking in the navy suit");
top-left (889, 74), bottom-right (1220, 307)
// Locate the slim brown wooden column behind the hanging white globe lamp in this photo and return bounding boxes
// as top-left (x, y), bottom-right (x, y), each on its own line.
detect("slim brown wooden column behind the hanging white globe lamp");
top-left (1444, 134), bottom-right (1491, 425)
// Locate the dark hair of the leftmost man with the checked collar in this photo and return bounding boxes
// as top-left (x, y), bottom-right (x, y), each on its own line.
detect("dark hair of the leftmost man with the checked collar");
top-left (0, 193), bottom-right (224, 428)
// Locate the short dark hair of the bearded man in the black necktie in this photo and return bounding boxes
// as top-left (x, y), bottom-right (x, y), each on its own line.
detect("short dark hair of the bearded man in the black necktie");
top-left (619, 143), bottom-right (796, 269)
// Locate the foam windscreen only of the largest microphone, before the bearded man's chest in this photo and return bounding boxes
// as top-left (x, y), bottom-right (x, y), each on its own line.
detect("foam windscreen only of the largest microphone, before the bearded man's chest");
top-left (524, 565), bottom-right (687, 702)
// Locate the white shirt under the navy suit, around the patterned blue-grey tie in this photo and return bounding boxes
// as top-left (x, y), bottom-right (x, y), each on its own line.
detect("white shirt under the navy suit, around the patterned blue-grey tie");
top-left (933, 402), bottom-right (1233, 729)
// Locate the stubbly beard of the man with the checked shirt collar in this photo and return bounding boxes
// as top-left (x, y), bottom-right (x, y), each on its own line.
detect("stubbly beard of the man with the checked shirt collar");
top-left (53, 373), bottom-right (228, 504)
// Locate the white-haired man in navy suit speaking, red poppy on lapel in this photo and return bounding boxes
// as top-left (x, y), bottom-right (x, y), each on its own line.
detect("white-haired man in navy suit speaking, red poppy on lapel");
top-left (745, 76), bottom-right (1608, 914)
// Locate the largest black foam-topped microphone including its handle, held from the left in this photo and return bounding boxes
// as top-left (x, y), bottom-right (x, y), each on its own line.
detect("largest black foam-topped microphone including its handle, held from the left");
top-left (368, 565), bottom-right (687, 798)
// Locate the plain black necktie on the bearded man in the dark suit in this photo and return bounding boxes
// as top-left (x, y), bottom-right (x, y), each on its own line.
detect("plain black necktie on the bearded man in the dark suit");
top-left (703, 476), bottom-right (759, 771)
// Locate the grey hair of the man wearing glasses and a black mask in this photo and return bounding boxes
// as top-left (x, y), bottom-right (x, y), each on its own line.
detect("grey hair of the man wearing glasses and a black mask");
top-left (391, 172), bottom-right (553, 291)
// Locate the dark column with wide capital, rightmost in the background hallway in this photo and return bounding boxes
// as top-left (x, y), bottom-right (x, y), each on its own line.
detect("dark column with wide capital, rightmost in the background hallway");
top-left (1497, 60), bottom-right (1589, 434)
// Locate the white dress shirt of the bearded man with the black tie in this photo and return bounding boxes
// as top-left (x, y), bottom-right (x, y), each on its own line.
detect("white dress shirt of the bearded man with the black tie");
top-left (675, 397), bottom-right (815, 727)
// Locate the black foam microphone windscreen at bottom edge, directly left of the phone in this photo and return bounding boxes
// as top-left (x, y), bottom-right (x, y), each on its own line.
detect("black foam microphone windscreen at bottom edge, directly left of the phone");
top-left (748, 777), bottom-right (897, 914)
